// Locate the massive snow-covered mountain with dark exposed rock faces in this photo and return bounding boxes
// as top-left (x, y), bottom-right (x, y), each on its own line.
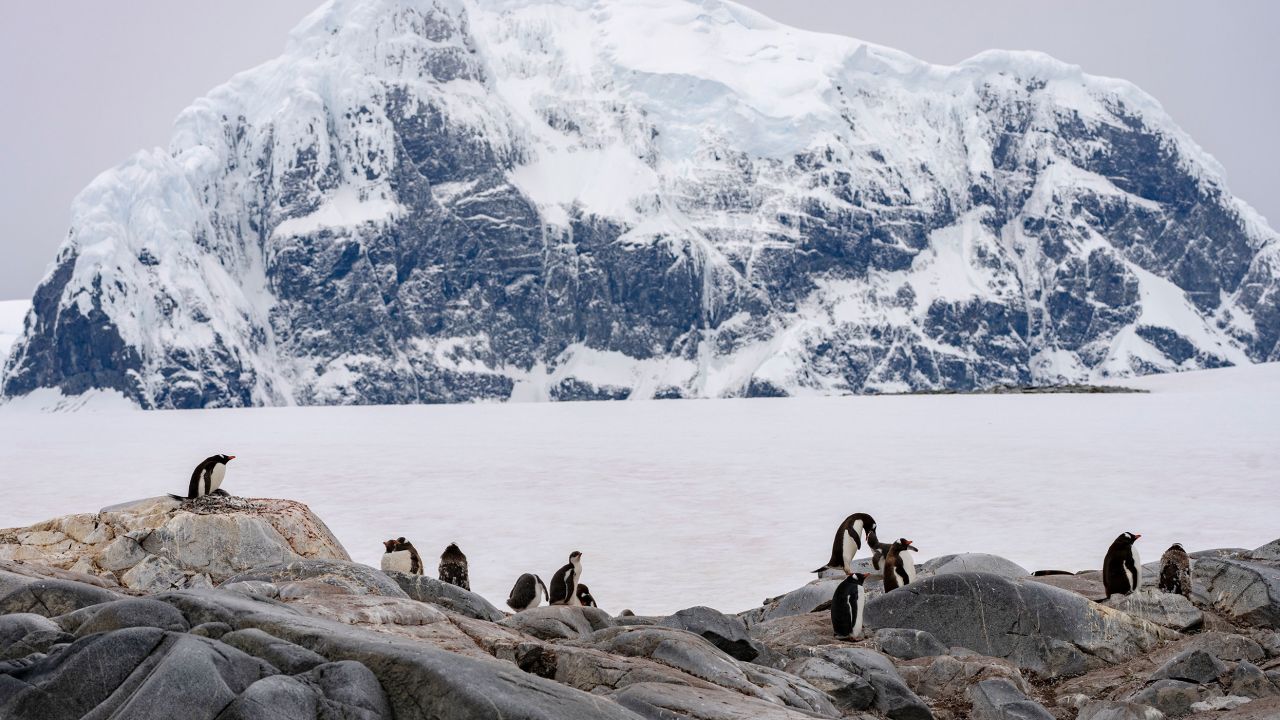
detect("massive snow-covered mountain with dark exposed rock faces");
top-left (3, 0), bottom-right (1280, 407)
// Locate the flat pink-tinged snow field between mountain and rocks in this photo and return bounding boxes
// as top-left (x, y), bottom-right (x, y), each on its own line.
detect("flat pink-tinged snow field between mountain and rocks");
top-left (0, 364), bottom-right (1280, 614)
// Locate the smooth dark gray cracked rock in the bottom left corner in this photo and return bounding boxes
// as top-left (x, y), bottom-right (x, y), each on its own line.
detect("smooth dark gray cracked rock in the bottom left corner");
top-left (0, 628), bottom-right (274, 720)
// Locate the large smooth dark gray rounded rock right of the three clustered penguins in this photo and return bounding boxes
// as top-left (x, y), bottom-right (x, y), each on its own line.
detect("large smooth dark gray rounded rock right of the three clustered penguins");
top-left (865, 573), bottom-right (1179, 678)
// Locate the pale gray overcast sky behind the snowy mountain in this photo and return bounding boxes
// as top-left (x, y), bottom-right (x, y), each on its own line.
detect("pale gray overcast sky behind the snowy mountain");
top-left (0, 0), bottom-right (1280, 299)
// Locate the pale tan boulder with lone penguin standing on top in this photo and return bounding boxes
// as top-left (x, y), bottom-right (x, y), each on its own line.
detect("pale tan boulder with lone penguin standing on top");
top-left (0, 496), bottom-right (351, 592)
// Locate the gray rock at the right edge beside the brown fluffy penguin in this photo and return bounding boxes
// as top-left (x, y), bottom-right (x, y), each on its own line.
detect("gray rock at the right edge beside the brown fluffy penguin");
top-left (1192, 557), bottom-right (1280, 628)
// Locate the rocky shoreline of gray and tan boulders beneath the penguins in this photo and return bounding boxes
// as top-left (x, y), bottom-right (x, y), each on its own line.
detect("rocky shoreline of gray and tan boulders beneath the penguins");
top-left (0, 497), bottom-right (1280, 720)
